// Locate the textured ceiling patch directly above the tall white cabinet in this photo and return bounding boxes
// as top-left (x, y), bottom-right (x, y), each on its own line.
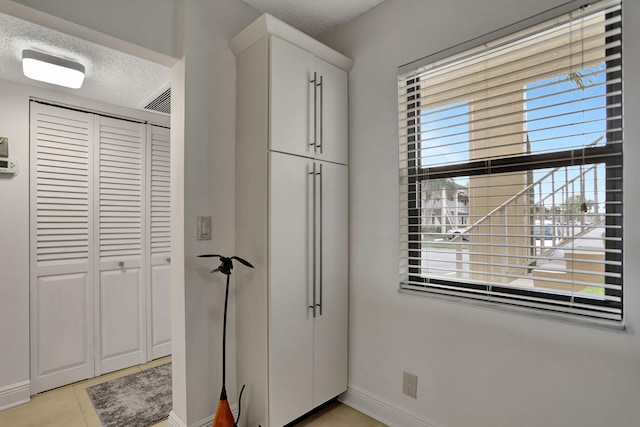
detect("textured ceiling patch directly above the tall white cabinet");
top-left (243, 0), bottom-right (383, 38)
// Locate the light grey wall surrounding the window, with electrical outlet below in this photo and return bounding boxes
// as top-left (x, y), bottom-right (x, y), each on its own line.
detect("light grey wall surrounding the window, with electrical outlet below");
top-left (324, 0), bottom-right (640, 427)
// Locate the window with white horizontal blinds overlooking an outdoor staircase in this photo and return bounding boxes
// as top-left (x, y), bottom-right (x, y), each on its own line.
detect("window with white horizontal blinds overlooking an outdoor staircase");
top-left (399, 0), bottom-right (623, 325)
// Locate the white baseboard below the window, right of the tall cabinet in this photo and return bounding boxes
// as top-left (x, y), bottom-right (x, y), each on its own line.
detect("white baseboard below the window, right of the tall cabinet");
top-left (338, 386), bottom-right (441, 427)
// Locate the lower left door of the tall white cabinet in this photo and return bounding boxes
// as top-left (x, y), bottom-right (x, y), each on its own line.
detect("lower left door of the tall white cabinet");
top-left (268, 153), bottom-right (313, 426)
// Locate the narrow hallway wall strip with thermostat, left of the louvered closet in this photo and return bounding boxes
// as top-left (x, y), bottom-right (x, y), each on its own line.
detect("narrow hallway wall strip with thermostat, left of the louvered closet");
top-left (0, 80), bottom-right (29, 408)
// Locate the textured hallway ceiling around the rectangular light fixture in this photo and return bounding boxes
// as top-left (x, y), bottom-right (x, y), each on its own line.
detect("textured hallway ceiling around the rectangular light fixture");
top-left (0, 14), bottom-right (171, 108)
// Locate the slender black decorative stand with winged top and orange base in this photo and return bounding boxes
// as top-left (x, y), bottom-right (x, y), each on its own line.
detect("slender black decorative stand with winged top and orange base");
top-left (198, 254), bottom-right (253, 427)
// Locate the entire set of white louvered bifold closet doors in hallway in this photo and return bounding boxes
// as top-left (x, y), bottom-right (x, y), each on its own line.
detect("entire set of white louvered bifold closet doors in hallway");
top-left (30, 102), bottom-right (171, 394)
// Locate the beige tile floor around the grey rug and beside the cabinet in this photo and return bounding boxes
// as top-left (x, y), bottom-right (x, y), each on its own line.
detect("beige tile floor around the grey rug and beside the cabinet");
top-left (0, 357), bottom-right (384, 427)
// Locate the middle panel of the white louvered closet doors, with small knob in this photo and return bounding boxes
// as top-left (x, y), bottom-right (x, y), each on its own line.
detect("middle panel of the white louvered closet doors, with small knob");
top-left (96, 117), bottom-right (146, 374)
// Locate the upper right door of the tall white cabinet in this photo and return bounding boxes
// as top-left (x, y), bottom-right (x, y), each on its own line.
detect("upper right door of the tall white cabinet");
top-left (313, 58), bottom-right (349, 164)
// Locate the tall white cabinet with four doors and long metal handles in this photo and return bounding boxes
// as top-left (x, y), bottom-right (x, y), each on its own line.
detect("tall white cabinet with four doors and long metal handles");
top-left (230, 15), bottom-right (352, 427)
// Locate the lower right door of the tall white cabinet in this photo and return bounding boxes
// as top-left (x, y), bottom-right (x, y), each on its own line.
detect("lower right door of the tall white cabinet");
top-left (313, 162), bottom-right (349, 406)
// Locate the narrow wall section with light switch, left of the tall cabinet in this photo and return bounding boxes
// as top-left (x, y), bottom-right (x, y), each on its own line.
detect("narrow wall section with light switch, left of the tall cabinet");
top-left (172, 0), bottom-right (258, 425)
